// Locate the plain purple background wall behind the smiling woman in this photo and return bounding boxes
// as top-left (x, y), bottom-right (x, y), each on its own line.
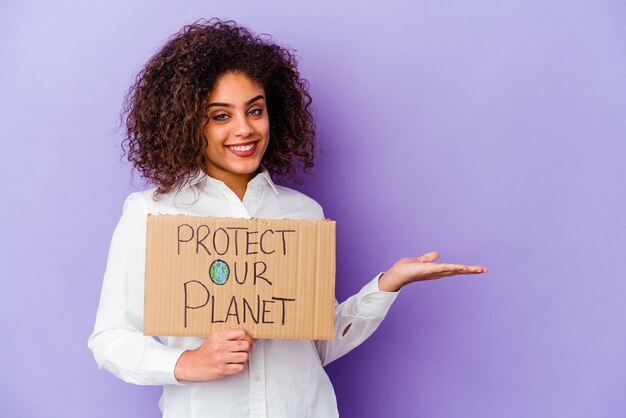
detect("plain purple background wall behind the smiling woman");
top-left (0, 0), bottom-right (626, 418)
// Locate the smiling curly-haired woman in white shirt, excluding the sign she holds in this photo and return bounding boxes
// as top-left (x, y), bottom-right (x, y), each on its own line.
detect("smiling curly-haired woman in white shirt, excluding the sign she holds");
top-left (89, 19), bottom-right (487, 418)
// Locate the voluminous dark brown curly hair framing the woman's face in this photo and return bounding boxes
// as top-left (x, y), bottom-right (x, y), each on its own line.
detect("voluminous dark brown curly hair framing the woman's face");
top-left (122, 19), bottom-right (315, 198)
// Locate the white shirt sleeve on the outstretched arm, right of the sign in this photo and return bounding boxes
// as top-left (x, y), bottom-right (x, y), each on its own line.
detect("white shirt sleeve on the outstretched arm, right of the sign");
top-left (315, 273), bottom-right (398, 366)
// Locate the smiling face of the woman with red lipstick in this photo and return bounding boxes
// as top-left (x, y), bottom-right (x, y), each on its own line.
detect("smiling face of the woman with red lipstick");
top-left (204, 73), bottom-right (270, 183)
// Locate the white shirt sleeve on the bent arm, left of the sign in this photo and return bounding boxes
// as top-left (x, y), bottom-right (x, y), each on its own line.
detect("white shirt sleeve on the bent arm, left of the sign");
top-left (88, 193), bottom-right (184, 385)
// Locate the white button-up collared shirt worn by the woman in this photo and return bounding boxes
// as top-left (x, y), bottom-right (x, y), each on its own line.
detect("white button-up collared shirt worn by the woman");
top-left (89, 172), bottom-right (398, 418)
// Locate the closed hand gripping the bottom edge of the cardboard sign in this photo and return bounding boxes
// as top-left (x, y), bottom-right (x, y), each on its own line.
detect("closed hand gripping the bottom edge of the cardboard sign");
top-left (174, 329), bottom-right (252, 382)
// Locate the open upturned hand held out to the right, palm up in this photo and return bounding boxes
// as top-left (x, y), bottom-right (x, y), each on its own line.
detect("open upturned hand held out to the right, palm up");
top-left (378, 251), bottom-right (487, 292)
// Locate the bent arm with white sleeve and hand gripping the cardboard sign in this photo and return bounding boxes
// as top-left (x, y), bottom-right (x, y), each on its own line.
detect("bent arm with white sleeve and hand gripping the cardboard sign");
top-left (88, 194), bottom-right (252, 385)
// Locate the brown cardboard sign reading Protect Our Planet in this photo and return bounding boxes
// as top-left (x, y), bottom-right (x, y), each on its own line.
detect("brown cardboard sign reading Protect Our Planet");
top-left (144, 215), bottom-right (335, 340)
